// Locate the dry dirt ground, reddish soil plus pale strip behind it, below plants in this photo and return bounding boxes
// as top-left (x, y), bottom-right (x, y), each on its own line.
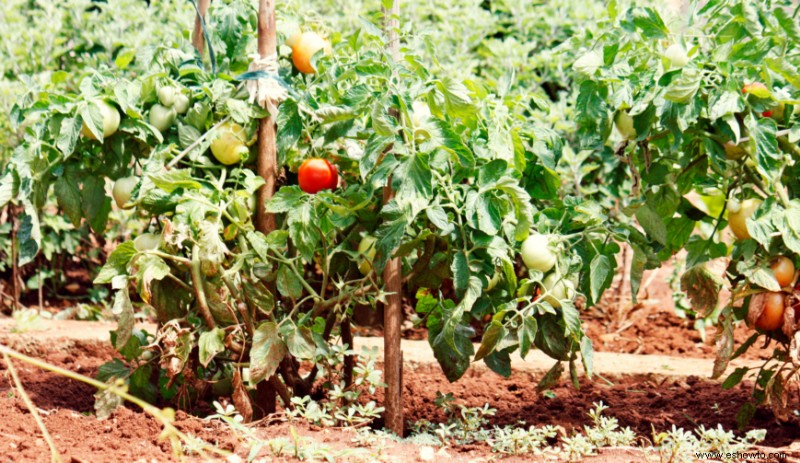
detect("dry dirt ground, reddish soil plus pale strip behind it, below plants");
top-left (0, 320), bottom-right (800, 463)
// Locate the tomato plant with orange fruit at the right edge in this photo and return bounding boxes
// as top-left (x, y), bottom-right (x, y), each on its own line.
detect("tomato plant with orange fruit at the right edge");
top-left (575, 1), bottom-right (800, 422)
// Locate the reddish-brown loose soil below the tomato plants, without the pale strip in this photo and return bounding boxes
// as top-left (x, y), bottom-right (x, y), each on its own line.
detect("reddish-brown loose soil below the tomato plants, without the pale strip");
top-left (0, 346), bottom-right (800, 463)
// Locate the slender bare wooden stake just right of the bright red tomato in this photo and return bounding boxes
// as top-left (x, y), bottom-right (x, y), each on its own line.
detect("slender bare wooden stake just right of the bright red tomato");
top-left (383, 0), bottom-right (403, 436)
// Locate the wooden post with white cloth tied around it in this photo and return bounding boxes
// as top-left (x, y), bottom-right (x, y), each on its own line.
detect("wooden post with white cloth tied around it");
top-left (255, 0), bottom-right (282, 414)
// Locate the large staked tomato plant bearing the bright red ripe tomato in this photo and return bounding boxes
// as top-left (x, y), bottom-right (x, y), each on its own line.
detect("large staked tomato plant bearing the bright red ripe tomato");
top-left (0, 2), bottom-right (622, 416)
